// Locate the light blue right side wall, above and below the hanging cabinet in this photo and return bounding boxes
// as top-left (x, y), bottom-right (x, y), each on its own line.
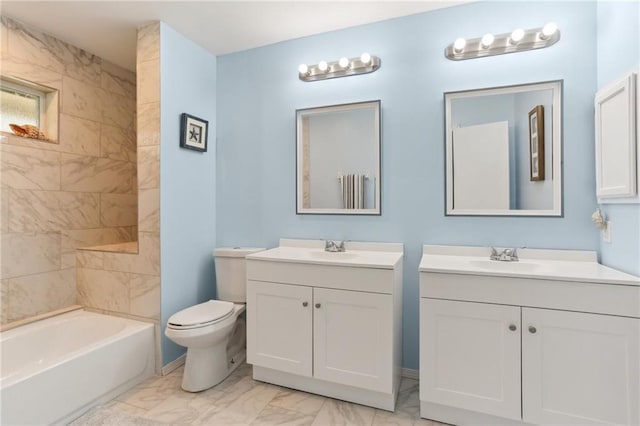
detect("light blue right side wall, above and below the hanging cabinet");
top-left (597, 1), bottom-right (640, 275)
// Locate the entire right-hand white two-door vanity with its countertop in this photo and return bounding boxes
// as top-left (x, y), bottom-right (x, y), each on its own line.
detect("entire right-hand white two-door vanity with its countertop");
top-left (420, 246), bottom-right (640, 425)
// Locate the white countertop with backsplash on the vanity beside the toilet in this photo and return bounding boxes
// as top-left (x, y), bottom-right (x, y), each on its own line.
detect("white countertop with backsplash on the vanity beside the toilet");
top-left (247, 239), bottom-right (403, 269)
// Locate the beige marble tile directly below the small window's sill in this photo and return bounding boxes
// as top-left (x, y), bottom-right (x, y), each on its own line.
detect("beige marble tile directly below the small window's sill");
top-left (0, 144), bottom-right (60, 190)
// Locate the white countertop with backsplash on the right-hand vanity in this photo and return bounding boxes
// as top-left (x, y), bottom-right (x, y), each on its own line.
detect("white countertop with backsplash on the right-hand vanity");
top-left (419, 245), bottom-right (640, 286)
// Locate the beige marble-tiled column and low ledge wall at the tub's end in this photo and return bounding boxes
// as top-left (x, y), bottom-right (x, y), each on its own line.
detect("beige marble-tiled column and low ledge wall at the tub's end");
top-left (77, 23), bottom-right (162, 373)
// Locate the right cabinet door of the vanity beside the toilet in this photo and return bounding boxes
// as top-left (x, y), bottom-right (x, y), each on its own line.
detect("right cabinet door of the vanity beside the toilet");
top-left (313, 288), bottom-right (393, 392)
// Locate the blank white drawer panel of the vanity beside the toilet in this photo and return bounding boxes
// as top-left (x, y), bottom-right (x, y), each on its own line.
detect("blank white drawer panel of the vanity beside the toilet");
top-left (247, 259), bottom-right (392, 294)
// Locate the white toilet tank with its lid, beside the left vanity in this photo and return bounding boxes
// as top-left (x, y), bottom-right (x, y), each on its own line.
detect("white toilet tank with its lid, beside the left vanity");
top-left (213, 247), bottom-right (264, 303)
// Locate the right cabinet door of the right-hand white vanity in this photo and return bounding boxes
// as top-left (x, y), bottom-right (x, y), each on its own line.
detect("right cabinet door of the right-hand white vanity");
top-left (522, 308), bottom-right (640, 425)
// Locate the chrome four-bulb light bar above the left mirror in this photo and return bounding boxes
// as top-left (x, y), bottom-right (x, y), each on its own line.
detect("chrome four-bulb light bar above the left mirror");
top-left (298, 53), bottom-right (381, 81)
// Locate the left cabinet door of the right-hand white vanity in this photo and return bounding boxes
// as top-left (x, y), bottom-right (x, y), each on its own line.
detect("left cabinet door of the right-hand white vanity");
top-left (420, 298), bottom-right (521, 420)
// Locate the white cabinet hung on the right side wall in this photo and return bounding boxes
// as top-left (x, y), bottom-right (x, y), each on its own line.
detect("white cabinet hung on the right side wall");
top-left (595, 73), bottom-right (640, 203)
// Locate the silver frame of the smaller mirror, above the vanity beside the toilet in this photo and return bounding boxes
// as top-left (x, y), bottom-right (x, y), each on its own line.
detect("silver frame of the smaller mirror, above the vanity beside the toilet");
top-left (296, 99), bottom-right (382, 216)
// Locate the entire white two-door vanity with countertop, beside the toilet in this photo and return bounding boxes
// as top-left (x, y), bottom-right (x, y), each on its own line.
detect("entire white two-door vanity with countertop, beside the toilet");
top-left (247, 239), bottom-right (403, 411)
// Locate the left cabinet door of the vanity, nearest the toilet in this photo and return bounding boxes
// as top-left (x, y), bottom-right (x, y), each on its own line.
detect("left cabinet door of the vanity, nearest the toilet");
top-left (247, 280), bottom-right (313, 376)
